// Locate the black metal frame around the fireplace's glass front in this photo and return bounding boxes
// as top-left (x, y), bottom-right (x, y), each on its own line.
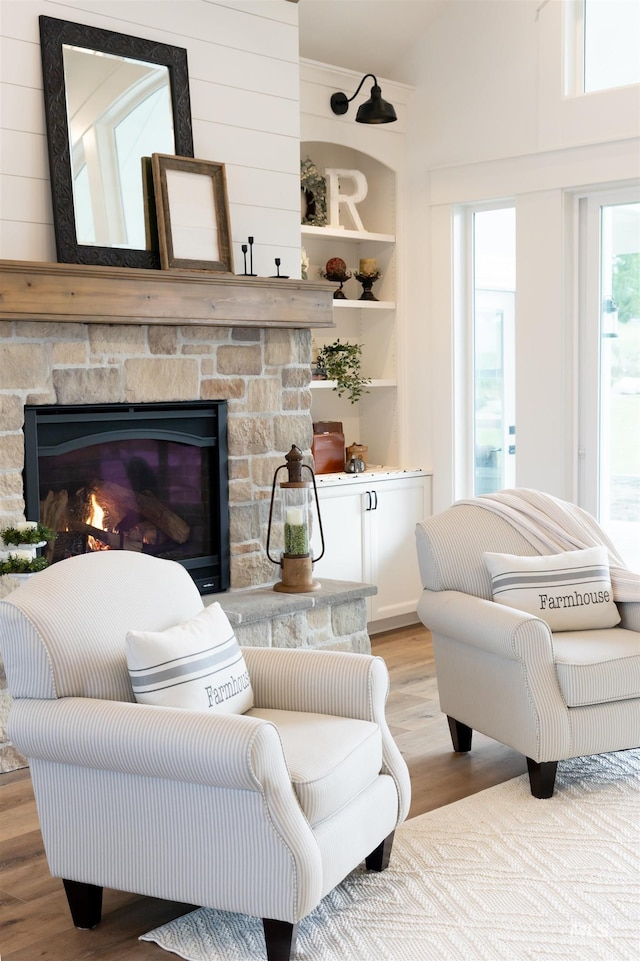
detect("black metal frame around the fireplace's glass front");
top-left (23, 400), bottom-right (230, 594)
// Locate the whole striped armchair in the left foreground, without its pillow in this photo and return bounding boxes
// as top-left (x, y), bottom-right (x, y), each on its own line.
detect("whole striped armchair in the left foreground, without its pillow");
top-left (0, 551), bottom-right (410, 961)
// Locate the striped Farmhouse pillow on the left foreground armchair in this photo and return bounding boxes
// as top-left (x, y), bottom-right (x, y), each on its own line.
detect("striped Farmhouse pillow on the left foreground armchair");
top-left (126, 601), bottom-right (253, 714)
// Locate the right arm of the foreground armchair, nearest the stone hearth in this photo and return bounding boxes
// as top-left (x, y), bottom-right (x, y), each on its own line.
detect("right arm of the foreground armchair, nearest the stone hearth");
top-left (242, 647), bottom-right (411, 824)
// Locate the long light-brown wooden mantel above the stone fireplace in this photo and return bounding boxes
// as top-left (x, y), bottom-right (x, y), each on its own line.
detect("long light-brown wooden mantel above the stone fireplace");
top-left (0, 260), bottom-right (334, 327)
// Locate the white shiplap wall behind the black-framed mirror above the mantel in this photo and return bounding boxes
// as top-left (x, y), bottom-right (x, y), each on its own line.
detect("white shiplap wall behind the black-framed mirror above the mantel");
top-left (0, 0), bottom-right (300, 277)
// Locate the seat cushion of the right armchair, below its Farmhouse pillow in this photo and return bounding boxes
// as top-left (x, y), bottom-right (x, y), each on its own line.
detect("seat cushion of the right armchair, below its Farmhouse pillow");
top-left (553, 627), bottom-right (640, 707)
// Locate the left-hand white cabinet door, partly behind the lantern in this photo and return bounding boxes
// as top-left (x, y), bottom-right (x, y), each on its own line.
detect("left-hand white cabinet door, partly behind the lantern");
top-left (311, 487), bottom-right (365, 583)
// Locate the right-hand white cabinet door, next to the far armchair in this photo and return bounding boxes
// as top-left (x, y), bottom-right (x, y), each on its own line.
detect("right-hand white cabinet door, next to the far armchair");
top-left (364, 476), bottom-right (431, 621)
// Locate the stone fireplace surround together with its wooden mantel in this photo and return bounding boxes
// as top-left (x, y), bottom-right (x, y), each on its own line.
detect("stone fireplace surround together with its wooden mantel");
top-left (0, 261), bottom-right (344, 589)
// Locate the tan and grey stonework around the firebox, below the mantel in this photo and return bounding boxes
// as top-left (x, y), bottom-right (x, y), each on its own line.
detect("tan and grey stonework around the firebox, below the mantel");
top-left (0, 320), bottom-right (312, 588)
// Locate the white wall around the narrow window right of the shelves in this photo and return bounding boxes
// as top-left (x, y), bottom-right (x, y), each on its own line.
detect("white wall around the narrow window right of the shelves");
top-left (406, 0), bottom-right (640, 510)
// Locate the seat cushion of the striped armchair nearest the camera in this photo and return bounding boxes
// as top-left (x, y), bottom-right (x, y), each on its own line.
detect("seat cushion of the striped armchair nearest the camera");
top-left (246, 708), bottom-right (382, 827)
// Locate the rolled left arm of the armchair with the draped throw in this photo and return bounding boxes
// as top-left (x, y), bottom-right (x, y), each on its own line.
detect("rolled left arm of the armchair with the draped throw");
top-left (418, 590), bottom-right (553, 664)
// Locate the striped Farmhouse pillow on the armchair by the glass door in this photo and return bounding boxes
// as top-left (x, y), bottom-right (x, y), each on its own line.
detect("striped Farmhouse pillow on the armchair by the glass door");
top-left (482, 547), bottom-right (620, 631)
